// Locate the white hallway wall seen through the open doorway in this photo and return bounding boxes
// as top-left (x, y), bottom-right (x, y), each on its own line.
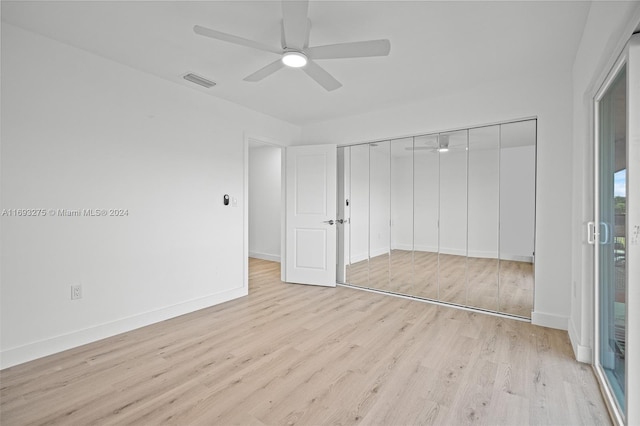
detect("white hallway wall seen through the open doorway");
top-left (249, 144), bottom-right (282, 262)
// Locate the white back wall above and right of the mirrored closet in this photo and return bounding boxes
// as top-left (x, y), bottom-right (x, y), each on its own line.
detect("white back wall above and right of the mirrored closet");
top-left (302, 67), bottom-right (572, 329)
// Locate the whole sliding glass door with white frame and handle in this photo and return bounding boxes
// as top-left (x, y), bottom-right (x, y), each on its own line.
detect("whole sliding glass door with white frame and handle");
top-left (590, 32), bottom-right (640, 424)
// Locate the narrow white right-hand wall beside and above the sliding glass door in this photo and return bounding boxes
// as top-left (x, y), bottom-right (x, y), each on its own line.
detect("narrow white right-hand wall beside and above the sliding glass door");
top-left (569, 2), bottom-right (640, 362)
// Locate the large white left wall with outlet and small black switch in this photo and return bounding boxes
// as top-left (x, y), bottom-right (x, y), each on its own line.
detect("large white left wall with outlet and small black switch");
top-left (0, 22), bottom-right (300, 367)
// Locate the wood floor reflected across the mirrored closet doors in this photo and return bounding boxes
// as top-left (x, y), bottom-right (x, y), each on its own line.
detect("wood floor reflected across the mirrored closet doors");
top-left (347, 250), bottom-right (533, 318)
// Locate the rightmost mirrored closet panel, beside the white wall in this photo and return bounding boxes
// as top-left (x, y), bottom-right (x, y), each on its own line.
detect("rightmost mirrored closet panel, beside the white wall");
top-left (499, 120), bottom-right (536, 318)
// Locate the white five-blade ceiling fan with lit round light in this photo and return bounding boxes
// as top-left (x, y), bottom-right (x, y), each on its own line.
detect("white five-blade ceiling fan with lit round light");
top-left (193, 0), bottom-right (391, 91)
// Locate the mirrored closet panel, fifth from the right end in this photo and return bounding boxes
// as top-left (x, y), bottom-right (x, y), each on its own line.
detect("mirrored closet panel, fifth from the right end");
top-left (390, 138), bottom-right (414, 294)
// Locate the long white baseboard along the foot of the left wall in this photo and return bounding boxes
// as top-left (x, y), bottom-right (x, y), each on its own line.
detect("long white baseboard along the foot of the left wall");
top-left (0, 287), bottom-right (248, 369)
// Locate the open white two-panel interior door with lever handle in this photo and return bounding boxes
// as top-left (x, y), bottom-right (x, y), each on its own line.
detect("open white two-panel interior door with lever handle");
top-left (285, 145), bottom-right (337, 287)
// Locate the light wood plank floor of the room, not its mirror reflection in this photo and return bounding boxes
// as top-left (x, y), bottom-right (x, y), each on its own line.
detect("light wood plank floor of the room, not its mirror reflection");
top-left (0, 259), bottom-right (610, 426)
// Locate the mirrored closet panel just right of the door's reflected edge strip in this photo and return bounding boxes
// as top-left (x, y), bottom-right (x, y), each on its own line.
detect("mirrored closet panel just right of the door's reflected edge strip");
top-left (345, 145), bottom-right (369, 287)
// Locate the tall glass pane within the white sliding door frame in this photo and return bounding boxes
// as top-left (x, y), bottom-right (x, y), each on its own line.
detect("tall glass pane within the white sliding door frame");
top-left (596, 66), bottom-right (627, 412)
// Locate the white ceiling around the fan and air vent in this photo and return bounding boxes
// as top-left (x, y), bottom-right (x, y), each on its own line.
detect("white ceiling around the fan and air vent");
top-left (2, 0), bottom-right (589, 125)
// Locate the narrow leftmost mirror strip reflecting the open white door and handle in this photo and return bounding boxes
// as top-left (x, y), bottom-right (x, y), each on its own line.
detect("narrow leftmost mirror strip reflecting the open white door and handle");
top-left (336, 146), bottom-right (351, 283)
